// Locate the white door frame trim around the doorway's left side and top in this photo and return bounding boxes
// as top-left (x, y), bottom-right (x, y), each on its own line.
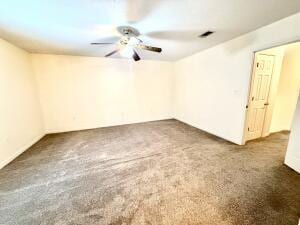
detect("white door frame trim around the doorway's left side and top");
top-left (242, 38), bottom-right (300, 145)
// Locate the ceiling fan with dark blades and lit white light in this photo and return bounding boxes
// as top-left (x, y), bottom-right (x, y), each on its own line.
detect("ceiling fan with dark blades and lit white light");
top-left (91, 26), bottom-right (162, 61)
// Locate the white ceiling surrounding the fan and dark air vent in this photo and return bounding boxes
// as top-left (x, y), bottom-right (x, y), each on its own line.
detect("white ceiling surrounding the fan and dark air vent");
top-left (0, 0), bottom-right (300, 60)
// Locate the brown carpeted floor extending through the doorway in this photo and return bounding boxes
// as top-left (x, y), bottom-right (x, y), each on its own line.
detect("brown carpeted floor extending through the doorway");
top-left (0, 120), bottom-right (300, 225)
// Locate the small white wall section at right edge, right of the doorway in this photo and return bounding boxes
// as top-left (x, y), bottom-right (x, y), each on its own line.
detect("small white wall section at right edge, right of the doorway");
top-left (285, 98), bottom-right (300, 173)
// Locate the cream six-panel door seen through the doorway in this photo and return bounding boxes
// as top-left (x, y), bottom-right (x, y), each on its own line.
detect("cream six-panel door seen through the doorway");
top-left (246, 54), bottom-right (275, 140)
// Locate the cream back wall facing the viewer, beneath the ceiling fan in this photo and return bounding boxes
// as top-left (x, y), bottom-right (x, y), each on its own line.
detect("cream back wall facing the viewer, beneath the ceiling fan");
top-left (32, 54), bottom-right (172, 132)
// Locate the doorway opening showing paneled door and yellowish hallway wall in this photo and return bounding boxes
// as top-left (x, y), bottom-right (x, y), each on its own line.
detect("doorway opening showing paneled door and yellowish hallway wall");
top-left (244, 42), bottom-right (300, 143)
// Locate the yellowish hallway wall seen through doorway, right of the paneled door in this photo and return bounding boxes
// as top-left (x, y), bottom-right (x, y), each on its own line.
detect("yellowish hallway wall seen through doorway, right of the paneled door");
top-left (270, 44), bottom-right (300, 132)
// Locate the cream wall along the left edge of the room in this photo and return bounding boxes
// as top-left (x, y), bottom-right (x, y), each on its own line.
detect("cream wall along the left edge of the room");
top-left (0, 39), bottom-right (44, 168)
